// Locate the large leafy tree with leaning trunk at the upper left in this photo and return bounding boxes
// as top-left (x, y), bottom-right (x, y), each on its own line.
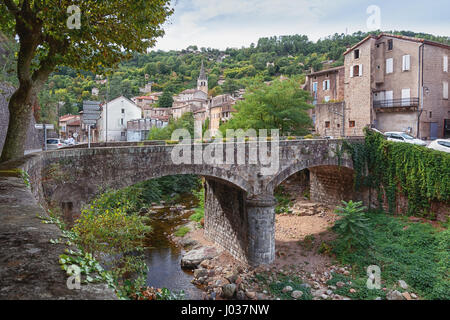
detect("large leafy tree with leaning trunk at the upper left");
top-left (0, 0), bottom-right (173, 161)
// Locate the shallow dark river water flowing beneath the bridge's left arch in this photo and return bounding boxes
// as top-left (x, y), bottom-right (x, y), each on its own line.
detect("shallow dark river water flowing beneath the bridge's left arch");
top-left (145, 194), bottom-right (202, 300)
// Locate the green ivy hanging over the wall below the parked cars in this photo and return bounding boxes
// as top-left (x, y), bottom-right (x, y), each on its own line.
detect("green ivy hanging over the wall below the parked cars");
top-left (344, 129), bottom-right (450, 216)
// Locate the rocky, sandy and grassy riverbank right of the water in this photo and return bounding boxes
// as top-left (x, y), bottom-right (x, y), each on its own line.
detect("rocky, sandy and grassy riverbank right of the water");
top-left (171, 172), bottom-right (450, 300)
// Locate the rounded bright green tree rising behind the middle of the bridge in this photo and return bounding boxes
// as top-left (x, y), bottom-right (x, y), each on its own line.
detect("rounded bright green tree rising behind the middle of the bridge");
top-left (220, 79), bottom-right (313, 135)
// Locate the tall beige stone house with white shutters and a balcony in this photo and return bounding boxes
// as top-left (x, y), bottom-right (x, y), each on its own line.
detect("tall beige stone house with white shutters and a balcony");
top-left (344, 34), bottom-right (450, 139)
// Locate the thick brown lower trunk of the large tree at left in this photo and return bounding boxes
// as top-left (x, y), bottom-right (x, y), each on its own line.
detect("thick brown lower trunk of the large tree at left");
top-left (0, 85), bottom-right (32, 162)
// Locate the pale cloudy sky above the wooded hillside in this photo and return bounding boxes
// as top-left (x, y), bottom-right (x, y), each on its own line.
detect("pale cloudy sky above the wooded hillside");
top-left (154, 0), bottom-right (450, 50)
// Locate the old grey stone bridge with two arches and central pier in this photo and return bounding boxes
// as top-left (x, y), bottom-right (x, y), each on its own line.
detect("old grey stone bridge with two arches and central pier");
top-left (4, 140), bottom-right (362, 266)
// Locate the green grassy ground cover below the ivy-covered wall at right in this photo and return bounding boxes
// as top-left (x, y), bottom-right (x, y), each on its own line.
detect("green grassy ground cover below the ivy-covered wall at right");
top-left (330, 212), bottom-right (450, 299)
